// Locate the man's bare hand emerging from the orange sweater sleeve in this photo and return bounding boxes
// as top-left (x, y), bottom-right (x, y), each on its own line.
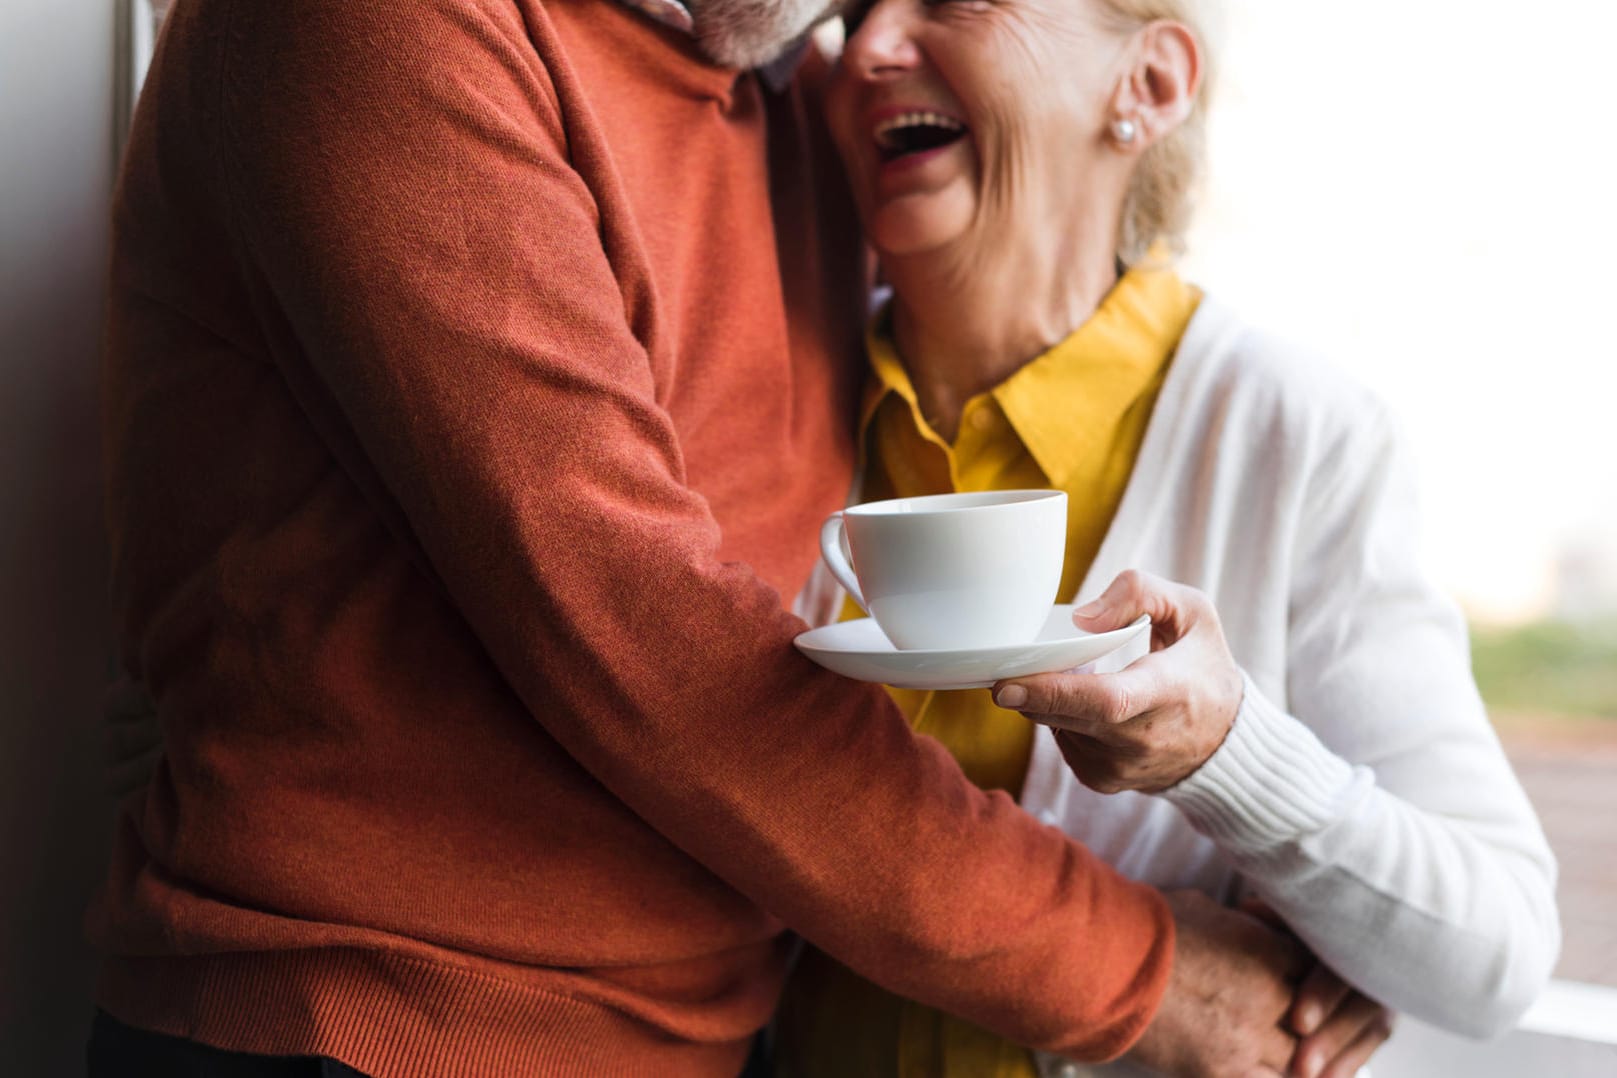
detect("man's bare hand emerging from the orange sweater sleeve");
top-left (1127, 891), bottom-right (1308, 1078)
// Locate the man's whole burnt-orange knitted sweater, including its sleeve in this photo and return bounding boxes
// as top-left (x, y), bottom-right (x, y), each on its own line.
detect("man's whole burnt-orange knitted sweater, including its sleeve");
top-left (92, 0), bottom-right (1172, 1076)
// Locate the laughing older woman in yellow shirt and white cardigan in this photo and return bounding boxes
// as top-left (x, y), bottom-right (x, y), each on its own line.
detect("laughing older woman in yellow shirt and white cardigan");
top-left (779, 0), bottom-right (1559, 1076)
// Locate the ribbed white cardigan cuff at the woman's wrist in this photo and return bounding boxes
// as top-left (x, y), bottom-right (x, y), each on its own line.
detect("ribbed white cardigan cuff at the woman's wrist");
top-left (1164, 672), bottom-right (1370, 855)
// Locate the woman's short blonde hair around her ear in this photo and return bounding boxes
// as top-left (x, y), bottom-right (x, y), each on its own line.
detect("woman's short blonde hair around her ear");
top-left (1101, 0), bottom-right (1214, 265)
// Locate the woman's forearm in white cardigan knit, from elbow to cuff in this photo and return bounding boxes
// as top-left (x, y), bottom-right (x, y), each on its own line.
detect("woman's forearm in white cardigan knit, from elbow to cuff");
top-left (1167, 682), bottom-right (1560, 1036)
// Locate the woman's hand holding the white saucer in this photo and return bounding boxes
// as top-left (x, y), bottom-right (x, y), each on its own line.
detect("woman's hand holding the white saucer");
top-left (994, 571), bottom-right (1243, 794)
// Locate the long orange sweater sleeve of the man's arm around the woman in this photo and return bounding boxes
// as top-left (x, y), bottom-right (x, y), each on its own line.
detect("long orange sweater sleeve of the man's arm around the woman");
top-left (208, 0), bottom-right (1172, 1059)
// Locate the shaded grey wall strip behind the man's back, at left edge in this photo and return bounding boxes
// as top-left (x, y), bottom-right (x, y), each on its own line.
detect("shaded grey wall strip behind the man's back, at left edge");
top-left (0, 0), bottom-right (115, 1078)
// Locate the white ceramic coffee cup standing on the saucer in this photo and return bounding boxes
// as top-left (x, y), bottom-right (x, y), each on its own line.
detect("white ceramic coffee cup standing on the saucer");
top-left (820, 490), bottom-right (1067, 650)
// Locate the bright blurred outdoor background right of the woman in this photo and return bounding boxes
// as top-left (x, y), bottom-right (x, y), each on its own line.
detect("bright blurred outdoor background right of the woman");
top-left (1187, 0), bottom-right (1617, 1002)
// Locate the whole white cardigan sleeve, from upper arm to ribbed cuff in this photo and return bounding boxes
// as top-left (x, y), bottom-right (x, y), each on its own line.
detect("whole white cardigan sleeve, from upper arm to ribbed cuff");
top-left (1166, 402), bottom-right (1560, 1036)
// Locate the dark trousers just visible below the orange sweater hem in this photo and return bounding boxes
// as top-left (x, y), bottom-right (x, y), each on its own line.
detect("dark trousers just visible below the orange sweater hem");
top-left (89, 1012), bottom-right (365, 1078)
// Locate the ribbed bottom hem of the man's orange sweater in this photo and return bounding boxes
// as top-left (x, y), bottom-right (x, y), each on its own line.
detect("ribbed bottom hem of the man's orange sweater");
top-left (97, 949), bottom-right (749, 1078)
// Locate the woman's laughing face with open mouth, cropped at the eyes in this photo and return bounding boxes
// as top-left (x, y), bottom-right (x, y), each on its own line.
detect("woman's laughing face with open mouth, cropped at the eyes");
top-left (826, 0), bottom-right (1129, 259)
